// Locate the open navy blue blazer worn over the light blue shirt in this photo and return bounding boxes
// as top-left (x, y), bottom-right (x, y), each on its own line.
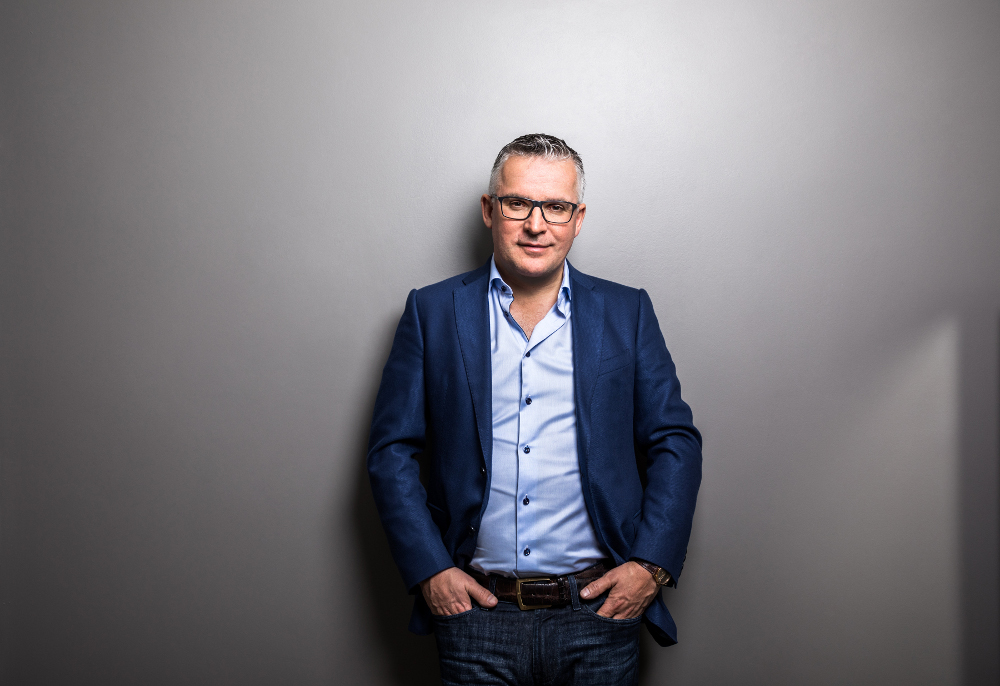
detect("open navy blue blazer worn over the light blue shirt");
top-left (368, 263), bottom-right (701, 645)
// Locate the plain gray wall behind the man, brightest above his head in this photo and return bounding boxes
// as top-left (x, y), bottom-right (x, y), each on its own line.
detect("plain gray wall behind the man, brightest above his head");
top-left (0, 0), bottom-right (1000, 685)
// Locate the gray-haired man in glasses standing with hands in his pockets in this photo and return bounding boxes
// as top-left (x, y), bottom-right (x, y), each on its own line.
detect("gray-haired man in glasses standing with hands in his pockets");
top-left (368, 134), bottom-right (701, 686)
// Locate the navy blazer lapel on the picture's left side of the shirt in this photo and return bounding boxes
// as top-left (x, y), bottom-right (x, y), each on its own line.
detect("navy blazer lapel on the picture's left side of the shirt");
top-left (454, 263), bottom-right (493, 470)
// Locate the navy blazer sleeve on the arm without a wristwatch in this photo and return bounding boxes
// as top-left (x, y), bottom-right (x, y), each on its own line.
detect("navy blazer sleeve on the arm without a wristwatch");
top-left (368, 291), bottom-right (454, 592)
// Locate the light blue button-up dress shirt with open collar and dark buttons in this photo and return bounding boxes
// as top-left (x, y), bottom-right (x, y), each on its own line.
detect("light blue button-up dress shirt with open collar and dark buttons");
top-left (471, 259), bottom-right (608, 577)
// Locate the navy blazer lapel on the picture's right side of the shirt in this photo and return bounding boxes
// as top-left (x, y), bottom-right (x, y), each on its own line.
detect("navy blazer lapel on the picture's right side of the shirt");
top-left (567, 263), bottom-right (604, 462)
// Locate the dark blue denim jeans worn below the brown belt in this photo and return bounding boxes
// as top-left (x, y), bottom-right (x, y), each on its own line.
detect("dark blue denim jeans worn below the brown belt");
top-left (434, 593), bottom-right (642, 686)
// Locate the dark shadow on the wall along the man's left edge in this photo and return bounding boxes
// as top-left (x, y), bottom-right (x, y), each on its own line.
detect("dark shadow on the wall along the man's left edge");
top-left (351, 210), bottom-right (493, 686)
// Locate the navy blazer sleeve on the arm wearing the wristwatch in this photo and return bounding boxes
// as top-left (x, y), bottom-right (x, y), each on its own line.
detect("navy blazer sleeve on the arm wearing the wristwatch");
top-left (630, 290), bottom-right (702, 583)
